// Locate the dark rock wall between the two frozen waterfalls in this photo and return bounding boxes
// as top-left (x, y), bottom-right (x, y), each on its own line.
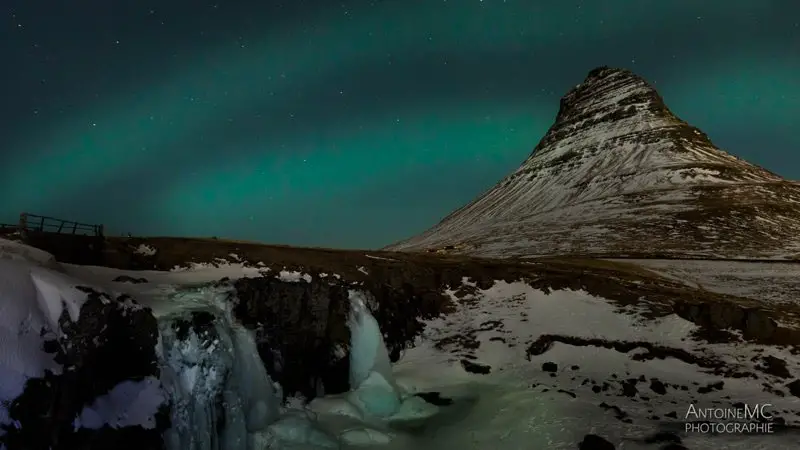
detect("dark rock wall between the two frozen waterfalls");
top-left (233, 278), bottom-right (350, 399)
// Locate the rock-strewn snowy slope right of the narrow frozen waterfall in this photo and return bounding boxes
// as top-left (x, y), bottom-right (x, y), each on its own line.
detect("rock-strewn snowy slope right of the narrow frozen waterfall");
top-left (394, 280), bottom-right (800, 449)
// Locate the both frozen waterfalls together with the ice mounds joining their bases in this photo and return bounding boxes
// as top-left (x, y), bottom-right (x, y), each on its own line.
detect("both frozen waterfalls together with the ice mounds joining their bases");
top-left (153, 286), bottom-right (435, 450)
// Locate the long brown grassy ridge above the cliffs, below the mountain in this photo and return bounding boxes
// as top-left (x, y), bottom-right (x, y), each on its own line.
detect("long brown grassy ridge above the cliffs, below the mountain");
top-left (92, 237), bottom-right (800, 344)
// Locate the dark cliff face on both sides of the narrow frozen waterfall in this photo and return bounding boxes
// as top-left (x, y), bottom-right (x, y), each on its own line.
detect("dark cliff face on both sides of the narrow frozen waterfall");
top-left (231, 264), bottom-right (462, 399)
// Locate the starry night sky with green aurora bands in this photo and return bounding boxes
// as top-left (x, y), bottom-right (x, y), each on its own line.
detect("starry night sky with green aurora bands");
top-left (0, 0), bottom-right (800, 248)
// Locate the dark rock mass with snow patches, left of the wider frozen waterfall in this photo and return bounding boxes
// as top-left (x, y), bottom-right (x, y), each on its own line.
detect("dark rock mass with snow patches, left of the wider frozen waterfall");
top-left (0, 255), bottom-right (164, 448)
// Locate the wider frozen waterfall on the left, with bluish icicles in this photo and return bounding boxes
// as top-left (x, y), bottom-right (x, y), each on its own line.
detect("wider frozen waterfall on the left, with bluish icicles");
top-left (159, 288), bottom-right (282, 450)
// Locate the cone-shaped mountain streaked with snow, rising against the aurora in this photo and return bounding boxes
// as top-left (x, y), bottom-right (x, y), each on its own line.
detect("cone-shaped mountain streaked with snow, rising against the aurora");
top-left (387, 67), bottom-right (800, 259)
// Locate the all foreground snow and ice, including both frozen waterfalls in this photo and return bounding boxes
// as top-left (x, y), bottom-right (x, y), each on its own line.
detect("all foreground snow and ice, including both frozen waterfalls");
top-left (0, 237), bottom-right (800, 450)
